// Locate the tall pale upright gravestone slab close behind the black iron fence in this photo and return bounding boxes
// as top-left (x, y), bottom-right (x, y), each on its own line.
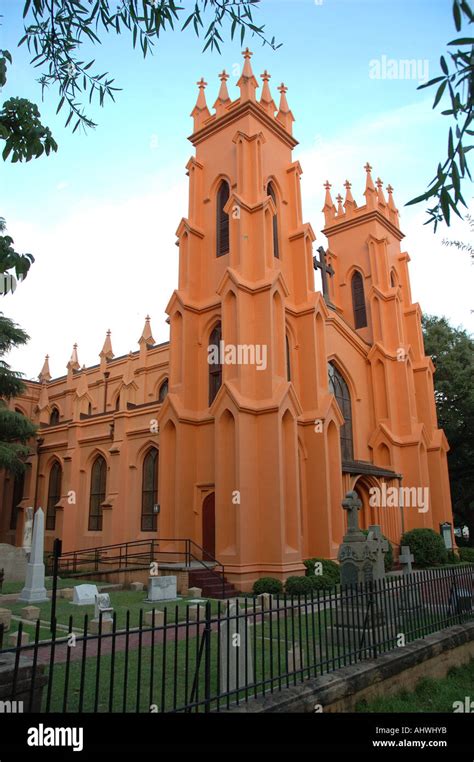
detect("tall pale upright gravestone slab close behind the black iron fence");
top-left (219, 601), bottom-right (254, 693)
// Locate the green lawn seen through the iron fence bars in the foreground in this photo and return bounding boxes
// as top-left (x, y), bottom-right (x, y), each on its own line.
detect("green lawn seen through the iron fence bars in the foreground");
top-left (43, 612), bottom-right (334, 712)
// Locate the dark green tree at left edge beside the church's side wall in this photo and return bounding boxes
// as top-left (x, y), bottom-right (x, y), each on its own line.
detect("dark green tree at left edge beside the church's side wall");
top-left (0, 313), bottom-right (37, 474)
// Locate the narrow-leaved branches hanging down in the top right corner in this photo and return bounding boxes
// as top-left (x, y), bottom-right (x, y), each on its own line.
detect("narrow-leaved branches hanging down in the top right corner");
top-left (407, 0), bottom-right (474, 231)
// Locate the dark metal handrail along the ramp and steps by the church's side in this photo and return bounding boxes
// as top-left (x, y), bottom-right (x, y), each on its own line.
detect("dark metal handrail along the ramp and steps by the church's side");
top-left (48, 537), bottom-right (225, 596)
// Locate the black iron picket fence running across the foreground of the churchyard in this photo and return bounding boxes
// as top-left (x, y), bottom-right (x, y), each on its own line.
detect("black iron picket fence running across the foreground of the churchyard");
top-left (0, 565), bottom-right (474, 712)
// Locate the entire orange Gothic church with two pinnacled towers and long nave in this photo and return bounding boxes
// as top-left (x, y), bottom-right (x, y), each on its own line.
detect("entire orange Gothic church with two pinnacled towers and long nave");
top-left (0, 50), bottom-right (452, 590)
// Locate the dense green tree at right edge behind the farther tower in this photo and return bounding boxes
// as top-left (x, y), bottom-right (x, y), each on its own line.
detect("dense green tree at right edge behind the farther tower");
top-left (423, 315), bottom-right (474, 545)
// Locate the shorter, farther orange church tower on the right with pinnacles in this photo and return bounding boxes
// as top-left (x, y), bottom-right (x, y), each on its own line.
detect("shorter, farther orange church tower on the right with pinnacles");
top-left (323, 163), bottom-right (451, 531)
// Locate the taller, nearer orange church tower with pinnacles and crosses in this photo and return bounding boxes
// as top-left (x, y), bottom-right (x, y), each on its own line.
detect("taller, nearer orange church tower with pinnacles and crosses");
top-left (160, 49), bottom-right (327, 586)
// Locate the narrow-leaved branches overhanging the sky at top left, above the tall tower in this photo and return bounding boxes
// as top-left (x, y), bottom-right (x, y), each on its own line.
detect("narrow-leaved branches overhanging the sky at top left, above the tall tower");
top-left (19, 0), bottom-right (279, 131)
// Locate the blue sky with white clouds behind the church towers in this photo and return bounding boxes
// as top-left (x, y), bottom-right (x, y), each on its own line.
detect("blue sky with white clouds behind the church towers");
top-left (0, 0), bottom-right (474, 378)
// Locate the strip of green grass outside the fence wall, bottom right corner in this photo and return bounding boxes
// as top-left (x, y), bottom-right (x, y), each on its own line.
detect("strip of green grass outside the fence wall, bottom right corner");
top-left (356, 659), bottom-right (474, 712)
